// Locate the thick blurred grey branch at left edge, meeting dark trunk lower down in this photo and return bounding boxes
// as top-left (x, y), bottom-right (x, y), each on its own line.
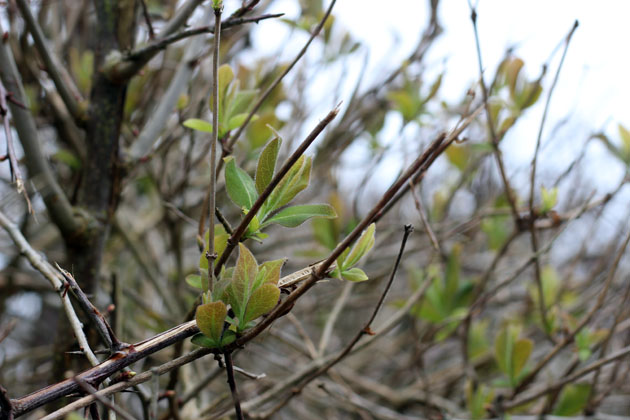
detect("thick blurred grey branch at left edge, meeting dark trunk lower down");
top-left (0, 23), bottom-right (83, 238)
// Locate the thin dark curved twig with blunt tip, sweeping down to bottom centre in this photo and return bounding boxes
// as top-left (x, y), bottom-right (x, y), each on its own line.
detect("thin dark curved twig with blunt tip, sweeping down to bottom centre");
top-left (254, 225), bottom-right (413, 417)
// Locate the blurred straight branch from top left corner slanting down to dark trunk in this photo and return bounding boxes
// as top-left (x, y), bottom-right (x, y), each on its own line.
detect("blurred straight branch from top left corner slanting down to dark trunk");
top-left (16, 0), bottom-right (87, 125)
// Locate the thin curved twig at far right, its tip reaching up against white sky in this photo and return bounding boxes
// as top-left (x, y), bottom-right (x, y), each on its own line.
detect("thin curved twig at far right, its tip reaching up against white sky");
top-left (529, 20), bottom-right (578, 341)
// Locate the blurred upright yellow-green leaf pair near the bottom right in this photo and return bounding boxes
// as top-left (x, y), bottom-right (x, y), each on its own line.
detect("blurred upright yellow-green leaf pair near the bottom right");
top-left (494, 325), bottom-right (534, 387)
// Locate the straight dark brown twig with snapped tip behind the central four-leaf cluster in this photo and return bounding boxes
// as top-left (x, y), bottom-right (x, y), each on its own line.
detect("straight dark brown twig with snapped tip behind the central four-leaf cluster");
top-left (214, 106), bottom-right (339, 275)
